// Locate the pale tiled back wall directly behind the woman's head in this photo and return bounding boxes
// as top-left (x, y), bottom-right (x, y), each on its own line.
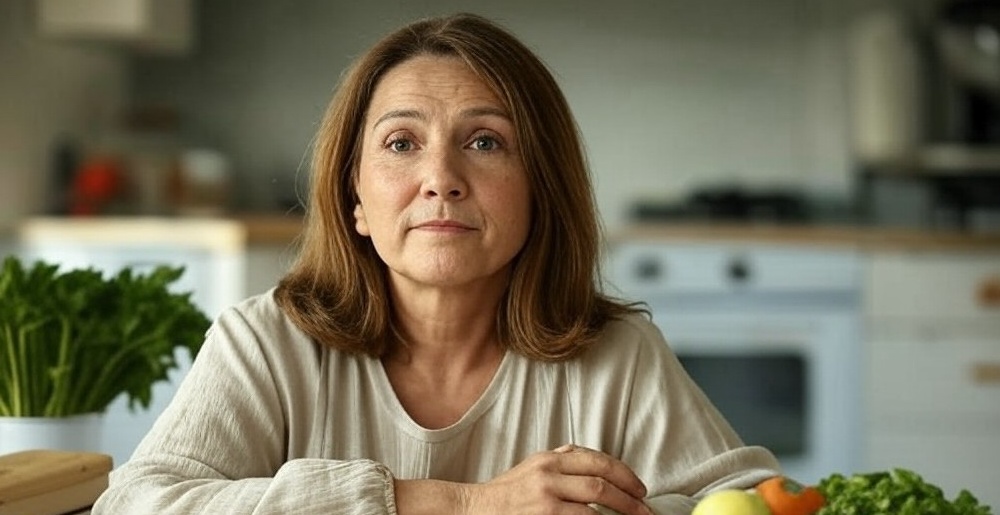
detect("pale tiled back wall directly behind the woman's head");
top-left (129, 0), bottom-right (904, 228)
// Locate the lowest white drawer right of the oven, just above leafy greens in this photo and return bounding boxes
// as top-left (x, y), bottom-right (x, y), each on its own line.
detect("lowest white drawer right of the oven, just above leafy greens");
top-left (865, 434), bottom-right (1000, 513)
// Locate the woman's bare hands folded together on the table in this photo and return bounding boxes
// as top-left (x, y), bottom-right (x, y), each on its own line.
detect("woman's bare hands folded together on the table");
top-left (465, 445), bottom-right (653, 515)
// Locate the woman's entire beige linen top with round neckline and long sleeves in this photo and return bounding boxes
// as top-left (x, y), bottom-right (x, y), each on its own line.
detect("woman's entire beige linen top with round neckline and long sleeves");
top-left (93, 292), bottom-right (779, 515)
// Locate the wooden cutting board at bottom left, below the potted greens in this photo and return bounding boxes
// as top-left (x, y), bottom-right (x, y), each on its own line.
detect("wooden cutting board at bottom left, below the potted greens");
top-left (0, 450), bottom-right (112, 515)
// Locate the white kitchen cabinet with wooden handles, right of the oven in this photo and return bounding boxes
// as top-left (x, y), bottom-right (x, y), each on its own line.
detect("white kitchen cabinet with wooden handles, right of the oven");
top-left (865, 250), bottom-right (1000, 507)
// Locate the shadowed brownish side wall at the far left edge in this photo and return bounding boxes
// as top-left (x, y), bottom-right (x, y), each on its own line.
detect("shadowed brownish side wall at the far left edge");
top-left (0, 0), bottom-right (127, 228)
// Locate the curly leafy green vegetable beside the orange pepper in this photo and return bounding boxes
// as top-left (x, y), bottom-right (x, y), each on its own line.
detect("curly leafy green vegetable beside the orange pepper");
top-left (817, 468), bottom-right (992, 515)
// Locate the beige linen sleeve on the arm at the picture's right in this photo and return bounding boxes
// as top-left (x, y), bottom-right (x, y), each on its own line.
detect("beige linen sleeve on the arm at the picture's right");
top-left (579, 317), bottom-right (780, 515)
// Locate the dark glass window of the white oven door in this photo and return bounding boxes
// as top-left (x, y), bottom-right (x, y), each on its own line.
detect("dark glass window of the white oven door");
top-left (678, 353), bottom-right (808, 459)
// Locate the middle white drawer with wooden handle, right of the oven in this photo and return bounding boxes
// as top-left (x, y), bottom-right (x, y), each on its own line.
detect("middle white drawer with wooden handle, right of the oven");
top-left (866, 336), bottom-right (1000, 422)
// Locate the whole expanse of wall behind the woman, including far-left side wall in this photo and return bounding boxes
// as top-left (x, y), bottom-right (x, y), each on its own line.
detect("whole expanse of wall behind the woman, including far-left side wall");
top-left (0, 0), bottom-right (944, 229)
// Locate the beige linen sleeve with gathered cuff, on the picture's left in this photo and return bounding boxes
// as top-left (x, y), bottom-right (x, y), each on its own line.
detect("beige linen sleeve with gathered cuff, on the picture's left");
top-left (93, 298), bottom-right (395, 515)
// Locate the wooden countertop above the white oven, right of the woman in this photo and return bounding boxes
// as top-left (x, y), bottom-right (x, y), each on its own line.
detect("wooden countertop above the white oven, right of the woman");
top-left (608, 223), bottom-right (1000, 251)
